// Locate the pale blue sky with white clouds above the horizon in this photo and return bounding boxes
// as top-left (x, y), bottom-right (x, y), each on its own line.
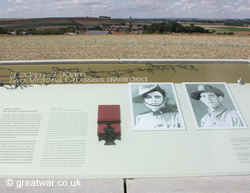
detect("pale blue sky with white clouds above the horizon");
top-left (0, 0), bottom-right (250, 19)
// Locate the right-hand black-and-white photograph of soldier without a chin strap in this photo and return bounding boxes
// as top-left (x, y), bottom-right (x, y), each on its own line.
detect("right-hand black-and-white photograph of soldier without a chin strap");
top-left (183, 82), bottom-right (247, 129)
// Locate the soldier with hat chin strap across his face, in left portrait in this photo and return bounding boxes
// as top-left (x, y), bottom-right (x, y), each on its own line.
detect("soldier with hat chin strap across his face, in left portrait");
top-left (133, 84), bottom-right (182, 129)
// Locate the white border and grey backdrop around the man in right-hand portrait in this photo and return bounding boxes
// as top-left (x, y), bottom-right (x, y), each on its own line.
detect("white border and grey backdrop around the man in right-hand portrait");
top-left (182, 82), bottom-right (248, 130)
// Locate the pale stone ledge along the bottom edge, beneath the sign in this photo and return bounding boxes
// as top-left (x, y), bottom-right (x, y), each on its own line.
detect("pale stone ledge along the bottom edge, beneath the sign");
top-left (0, 176), bottom-right (250, 193)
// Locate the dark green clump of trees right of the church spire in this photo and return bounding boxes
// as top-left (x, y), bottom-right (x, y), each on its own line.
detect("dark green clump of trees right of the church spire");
top-left (142, 21), bottom-right (210, 34)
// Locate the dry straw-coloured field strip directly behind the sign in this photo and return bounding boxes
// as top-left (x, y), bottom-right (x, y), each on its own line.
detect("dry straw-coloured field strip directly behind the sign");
top-left (0, 35), bottom-right (250, 60)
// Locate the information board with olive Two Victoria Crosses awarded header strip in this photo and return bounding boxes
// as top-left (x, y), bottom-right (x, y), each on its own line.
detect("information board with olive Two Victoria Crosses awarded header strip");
top-left (0, 60), bottom-right (250, 178)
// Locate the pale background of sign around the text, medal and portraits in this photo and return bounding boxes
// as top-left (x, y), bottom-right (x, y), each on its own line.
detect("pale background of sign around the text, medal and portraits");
top-left (0, 84), bottom-right (250, 178)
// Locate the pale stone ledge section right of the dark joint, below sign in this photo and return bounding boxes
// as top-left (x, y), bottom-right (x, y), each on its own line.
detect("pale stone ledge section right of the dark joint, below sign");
top-left (127, 176), bottom-right (250, 193)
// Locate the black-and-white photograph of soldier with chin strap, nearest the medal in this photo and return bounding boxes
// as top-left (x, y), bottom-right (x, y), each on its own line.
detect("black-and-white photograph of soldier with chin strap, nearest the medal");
top-left (129, 83), bottom-right (185, 130)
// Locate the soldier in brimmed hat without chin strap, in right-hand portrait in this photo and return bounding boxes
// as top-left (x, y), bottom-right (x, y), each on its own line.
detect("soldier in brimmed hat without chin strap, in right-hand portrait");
top-left (190, 85), bottom-right (243, 128)
